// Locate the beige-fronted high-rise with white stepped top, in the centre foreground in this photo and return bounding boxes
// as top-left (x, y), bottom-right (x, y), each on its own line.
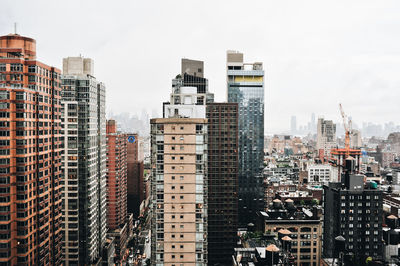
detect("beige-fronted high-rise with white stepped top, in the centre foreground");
top-left (150, 61), bottom-right (213, 265)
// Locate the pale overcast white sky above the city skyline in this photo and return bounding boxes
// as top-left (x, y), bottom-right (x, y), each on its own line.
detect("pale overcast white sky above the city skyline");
top-left (0, 0), bottom-right (400, 133)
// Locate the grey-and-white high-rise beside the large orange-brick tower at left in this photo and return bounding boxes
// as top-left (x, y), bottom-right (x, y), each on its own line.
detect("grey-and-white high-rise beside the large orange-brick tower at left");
top-left (62, 57), bottom-right (107, 265)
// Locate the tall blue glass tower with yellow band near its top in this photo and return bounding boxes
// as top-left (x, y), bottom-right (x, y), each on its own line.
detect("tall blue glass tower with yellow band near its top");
top-left (227, 51), bottom-right (264, 226)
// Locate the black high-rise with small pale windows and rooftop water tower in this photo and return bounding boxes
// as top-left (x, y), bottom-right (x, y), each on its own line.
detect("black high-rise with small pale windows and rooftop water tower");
top-left (323, 157), bottom-right (383, 261)
